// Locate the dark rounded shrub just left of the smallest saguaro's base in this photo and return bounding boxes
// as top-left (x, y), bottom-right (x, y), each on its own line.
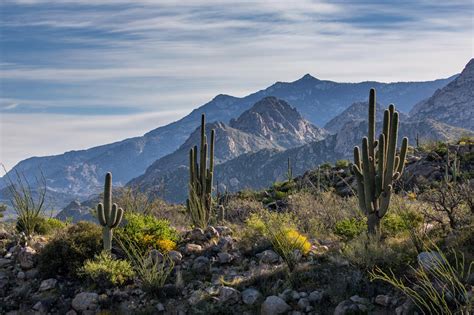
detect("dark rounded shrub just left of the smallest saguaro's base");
top-left (38, 222), bottom-right (102, 277)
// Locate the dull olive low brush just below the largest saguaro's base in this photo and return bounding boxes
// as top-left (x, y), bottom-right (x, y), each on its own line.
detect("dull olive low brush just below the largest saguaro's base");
top-left (342, 233), bottom-right (417, 270)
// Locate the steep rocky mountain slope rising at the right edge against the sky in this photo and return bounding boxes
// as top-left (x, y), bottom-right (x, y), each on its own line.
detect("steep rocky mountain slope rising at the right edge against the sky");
top-left (410, 59), bottom-right (474, 130)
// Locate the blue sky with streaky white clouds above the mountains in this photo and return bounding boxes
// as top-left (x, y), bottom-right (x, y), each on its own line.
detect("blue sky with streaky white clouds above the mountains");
top-left (0, 0), bottom-right (474, 173)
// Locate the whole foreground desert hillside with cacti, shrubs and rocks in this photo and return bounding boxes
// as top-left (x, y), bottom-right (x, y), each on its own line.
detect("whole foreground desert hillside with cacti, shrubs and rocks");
top-left (0, 90), bottom-right (474, 315)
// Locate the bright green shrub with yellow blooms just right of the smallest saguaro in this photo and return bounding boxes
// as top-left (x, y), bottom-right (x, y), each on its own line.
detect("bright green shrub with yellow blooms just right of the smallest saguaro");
top-left (116, 212), bottom-right (179, 252)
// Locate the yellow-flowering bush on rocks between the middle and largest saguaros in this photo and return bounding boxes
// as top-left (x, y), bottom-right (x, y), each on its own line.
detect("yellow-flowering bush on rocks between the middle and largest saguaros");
top-left (247, 211), bottom-right (311, 271)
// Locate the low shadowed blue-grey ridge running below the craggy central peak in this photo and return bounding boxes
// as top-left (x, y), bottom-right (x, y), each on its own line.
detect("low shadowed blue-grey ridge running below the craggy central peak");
top-left (143, 119), bottom-right (472, 202)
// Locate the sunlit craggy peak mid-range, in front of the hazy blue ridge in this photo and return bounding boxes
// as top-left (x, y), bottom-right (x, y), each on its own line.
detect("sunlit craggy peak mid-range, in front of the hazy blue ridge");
top-left (130, 97), bottom-right (327, 193)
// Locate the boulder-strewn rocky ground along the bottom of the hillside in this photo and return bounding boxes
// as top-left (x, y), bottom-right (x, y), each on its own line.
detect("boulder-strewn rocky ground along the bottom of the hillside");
top-left (0, 226), bottom-right (422, 315)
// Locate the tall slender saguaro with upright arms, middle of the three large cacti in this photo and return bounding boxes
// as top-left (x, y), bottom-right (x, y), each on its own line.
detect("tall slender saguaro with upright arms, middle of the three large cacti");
top-left (186, 114), bottom-right (215, 228)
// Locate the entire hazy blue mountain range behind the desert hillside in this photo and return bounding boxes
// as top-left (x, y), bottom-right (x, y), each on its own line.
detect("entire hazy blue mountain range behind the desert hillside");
top-left (1, 60), bottom-right (474, 212)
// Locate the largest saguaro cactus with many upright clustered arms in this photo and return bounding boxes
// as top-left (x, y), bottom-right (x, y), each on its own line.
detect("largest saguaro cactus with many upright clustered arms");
top-left (352, 89), bottom-right (408, 234)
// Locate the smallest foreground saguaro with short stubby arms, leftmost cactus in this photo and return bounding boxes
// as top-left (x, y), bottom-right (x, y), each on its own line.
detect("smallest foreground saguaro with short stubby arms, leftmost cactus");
top-left (97, 172), bottom-right (123, 251)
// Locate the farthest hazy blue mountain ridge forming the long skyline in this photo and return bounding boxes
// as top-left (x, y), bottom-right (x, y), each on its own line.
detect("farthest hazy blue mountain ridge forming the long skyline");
top-left (0, 75), bottom-right (454, 210)
